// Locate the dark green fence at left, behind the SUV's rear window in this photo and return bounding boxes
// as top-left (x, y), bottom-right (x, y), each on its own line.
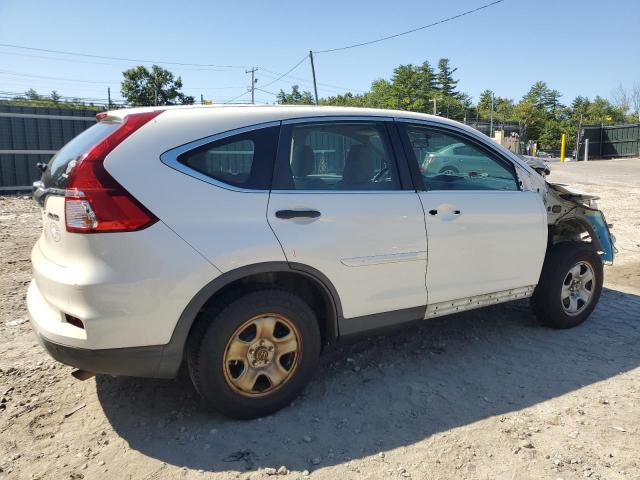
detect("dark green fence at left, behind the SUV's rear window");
top-left (0, 104), bottom-right (96, 191)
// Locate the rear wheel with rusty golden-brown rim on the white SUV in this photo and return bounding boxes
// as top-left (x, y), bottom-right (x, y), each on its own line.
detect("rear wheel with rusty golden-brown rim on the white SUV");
top-left (188, 288), bottom-right (320, 419)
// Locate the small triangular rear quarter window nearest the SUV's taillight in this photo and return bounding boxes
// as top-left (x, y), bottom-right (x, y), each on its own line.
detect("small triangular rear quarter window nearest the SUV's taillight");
top-left (178, 127), bottom-right (279, 190)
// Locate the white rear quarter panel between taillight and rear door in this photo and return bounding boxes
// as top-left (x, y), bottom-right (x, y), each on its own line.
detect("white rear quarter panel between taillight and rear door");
top-left (105, 107), bottom-right (285, 272)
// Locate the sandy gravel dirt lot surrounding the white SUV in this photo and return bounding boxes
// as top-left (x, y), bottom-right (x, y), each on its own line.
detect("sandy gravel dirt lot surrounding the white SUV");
top-left (0, 160), bottom-right (640, 480)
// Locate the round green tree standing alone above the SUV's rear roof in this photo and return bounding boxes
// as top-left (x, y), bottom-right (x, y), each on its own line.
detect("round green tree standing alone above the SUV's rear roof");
top-left (120, 65), bottom-right (194, 106)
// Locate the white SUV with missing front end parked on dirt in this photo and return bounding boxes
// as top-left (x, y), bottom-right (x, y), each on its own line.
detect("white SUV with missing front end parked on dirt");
top-left (27, 106), bottom-right (614, 418)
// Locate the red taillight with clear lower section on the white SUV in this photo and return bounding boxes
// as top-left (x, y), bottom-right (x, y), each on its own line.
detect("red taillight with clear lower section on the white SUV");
top-left (65, 110), bottom-right (163, 233)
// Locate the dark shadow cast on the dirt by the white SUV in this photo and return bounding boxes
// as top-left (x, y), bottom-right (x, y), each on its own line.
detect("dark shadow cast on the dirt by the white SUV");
top-left (96, 289), bottom-right (640, 472)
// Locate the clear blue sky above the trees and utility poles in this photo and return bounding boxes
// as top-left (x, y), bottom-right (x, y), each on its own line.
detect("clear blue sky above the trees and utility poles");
top-left (0, 0), bottom-right (640, 103)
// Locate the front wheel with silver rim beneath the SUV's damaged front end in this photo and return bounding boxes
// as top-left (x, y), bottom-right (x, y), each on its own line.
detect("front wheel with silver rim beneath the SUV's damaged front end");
top-left (531, 242), bottom-right (604, 329)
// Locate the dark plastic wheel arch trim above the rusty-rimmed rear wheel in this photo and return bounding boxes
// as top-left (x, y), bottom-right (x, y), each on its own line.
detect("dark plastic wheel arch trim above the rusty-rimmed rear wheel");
top-left (160, 262), bottom-right (342, 376)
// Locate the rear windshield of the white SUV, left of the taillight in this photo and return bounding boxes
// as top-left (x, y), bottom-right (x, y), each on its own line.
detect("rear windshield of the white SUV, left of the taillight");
top-left (42, 122), bottom-right (120, 189)
